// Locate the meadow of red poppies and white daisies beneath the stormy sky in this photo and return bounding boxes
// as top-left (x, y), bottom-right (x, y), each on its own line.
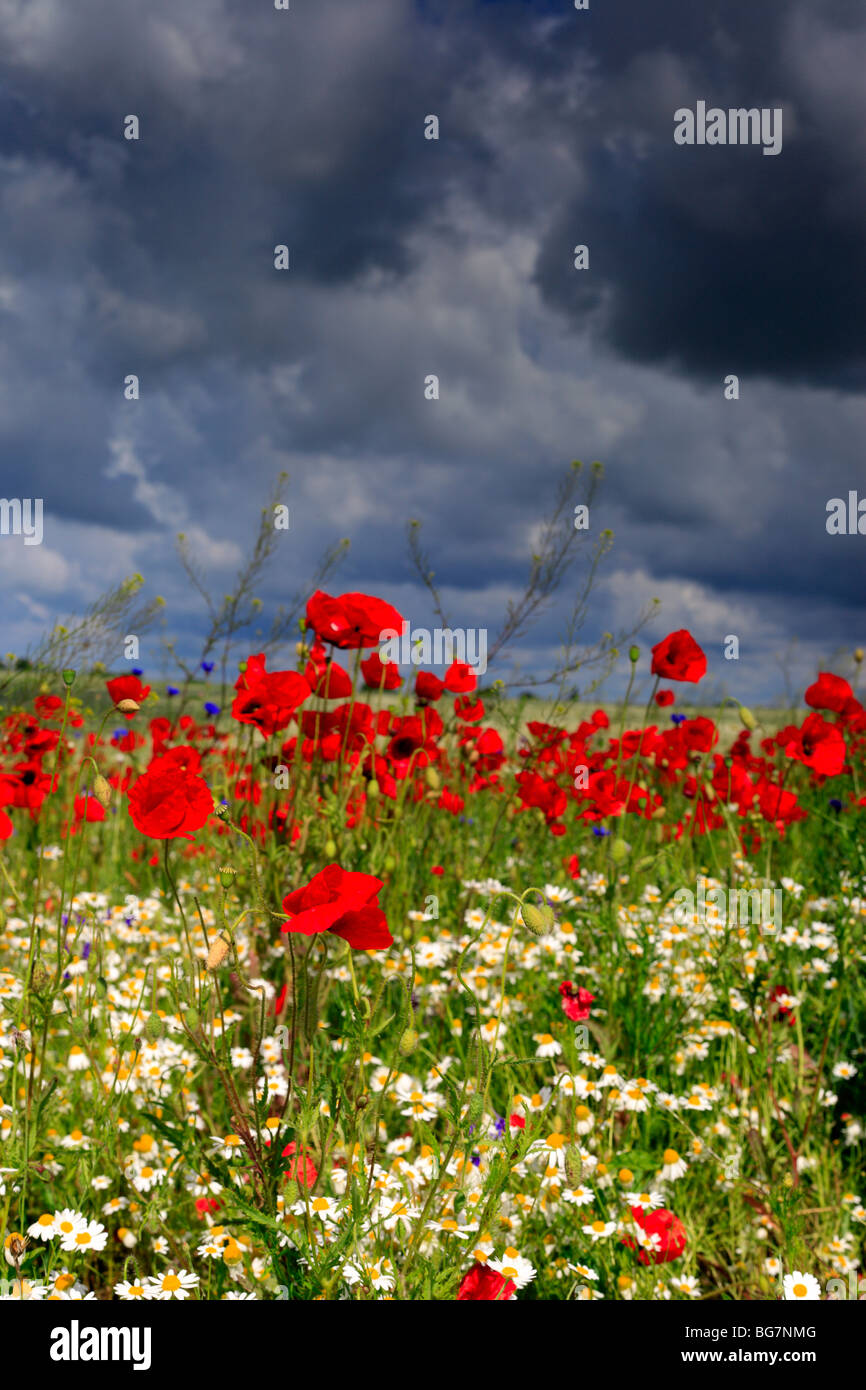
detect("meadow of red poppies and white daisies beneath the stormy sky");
top-left (0, 589), bottom-right (866, 1301)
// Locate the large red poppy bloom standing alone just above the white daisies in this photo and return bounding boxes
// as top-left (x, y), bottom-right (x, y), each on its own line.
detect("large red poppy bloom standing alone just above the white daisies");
top-left (281, 865), bottom-right (393, 951)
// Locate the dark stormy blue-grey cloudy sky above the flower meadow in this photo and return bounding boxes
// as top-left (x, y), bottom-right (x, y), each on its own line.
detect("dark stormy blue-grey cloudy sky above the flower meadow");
top-left (0, 0), bottom-right (866, 701)
